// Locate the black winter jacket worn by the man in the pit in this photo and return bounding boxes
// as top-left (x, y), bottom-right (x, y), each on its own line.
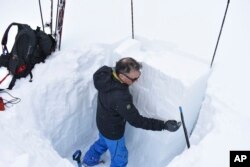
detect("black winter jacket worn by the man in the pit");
top-left (93, 66), bottom-right (164, 140)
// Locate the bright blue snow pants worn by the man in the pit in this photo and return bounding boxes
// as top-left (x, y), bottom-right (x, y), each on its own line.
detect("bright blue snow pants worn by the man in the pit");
top-left (83, 133), bottom-right (128, 167)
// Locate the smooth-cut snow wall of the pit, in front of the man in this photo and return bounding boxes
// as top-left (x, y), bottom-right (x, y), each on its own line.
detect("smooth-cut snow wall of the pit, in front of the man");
top-left (115, 40), bottom-right (209, 167)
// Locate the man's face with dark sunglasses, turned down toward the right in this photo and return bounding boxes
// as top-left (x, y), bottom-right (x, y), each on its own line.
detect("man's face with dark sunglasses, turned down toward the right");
top-left (119, 70), bottom-right (141, 85)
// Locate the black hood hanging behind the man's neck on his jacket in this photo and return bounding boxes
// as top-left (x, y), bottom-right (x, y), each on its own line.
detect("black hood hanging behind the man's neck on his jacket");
top-left (93, 66), bottom-right (128, 92)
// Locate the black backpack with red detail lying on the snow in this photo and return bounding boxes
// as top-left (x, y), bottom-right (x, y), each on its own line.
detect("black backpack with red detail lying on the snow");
top-left (0, 23), bottom-right (56, 89)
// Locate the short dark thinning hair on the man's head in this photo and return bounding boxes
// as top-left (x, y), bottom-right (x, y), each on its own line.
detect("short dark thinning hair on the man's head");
top-left (115, 57), bottom-right (142, 74)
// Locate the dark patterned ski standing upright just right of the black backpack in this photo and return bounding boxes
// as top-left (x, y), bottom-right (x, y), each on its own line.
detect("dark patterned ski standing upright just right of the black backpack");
top-left (55, 0), bottom-right (66, 50)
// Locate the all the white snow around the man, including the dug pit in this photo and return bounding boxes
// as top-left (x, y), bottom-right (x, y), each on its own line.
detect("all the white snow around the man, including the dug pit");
top-left (0, 0), bottom-right (250, 167)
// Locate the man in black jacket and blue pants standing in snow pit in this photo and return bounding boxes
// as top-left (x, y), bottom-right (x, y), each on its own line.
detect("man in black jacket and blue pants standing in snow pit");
top-left (83, 57), bottom-right (181, 167)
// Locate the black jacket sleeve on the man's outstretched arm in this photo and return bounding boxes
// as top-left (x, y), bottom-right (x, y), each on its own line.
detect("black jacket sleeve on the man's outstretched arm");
top-left (115, 90), bottom-right (164, 131)
